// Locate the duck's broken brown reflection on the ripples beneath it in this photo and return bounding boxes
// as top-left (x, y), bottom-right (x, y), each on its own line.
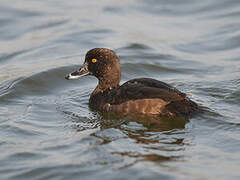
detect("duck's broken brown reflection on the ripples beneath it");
top-left (69, 114), bottom-right (189, 169)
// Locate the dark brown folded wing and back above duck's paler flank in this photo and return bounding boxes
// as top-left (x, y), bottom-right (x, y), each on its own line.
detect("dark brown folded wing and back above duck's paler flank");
top-left (109, 78), bottom-right (186, 104)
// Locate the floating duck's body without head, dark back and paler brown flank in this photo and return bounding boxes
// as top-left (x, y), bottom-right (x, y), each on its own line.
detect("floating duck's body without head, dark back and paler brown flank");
top-left (89, 78), bottom-right (198, 116)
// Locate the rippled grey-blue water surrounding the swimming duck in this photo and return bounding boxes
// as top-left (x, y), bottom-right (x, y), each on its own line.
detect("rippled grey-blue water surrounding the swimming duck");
top-left (0, 0), bottom-right (240, 180)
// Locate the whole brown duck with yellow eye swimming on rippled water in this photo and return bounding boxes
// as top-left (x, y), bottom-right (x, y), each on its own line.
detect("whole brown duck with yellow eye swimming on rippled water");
top-left (65, 48), bottom-right (199, 117)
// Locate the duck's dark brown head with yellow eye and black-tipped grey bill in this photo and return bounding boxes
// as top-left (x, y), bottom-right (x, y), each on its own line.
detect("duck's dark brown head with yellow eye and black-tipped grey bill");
top-left (65, 48), bottom-right (121, 90)
